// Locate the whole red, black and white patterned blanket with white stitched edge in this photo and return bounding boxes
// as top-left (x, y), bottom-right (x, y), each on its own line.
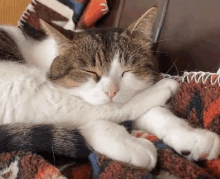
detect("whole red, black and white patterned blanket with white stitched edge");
top-left (0, 0), bottom-right (220, 179)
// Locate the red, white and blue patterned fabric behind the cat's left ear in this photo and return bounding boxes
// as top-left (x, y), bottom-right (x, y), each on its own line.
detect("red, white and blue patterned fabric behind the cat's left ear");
top-left (18, 0), bottom-right (109, 40)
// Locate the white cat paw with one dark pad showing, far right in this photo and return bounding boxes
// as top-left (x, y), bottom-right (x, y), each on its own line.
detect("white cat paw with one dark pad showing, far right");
top-left (164, 129), bottom-right (220, 161)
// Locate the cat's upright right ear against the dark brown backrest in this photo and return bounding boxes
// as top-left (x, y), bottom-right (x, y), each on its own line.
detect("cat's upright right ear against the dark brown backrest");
top-left (127, 7), bottom-right (158, 34)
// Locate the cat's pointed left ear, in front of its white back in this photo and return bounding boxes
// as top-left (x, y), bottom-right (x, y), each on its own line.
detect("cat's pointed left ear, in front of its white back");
top-left (39, 19), bottom-right (71, 55)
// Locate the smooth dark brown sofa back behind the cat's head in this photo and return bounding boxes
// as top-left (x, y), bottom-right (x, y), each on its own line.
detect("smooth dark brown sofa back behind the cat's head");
top-left (97, 0), bottom-right (220, 74)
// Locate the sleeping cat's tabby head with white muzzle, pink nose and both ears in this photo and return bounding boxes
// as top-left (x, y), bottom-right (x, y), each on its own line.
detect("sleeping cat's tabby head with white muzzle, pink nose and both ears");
top-left (41, 7), bottom-right (157, 107)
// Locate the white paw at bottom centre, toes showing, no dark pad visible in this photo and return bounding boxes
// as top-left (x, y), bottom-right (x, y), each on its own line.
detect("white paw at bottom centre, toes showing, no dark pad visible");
top-left (126, 137), bottom-right (157, 170)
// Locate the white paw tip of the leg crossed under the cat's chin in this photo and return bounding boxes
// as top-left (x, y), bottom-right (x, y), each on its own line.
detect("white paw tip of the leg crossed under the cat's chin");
top-left (156, 78), bottom-right (179, 95)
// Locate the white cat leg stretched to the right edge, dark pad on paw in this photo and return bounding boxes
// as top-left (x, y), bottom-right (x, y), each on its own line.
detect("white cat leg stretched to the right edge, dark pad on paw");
top-left (134, 107), bottom-right (220, 160)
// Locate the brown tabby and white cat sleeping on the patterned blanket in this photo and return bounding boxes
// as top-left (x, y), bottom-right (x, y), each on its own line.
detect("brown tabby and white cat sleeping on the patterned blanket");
top-left (0, 8), bottom-right (220, 170)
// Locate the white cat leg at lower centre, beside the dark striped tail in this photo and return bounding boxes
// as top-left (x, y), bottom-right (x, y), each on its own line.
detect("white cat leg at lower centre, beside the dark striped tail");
top-left (80, 120), bottom-right (157, 170)
